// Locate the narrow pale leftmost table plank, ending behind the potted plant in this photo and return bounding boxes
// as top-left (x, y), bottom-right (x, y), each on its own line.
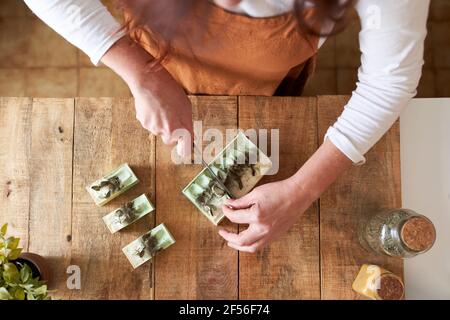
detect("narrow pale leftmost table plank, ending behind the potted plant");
top-left (0, 98), bottom-right (32, 251)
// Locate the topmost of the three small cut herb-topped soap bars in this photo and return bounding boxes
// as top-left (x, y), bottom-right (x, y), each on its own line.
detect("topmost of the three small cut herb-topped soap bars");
top-left (86, 163), bottom-right (139, 206)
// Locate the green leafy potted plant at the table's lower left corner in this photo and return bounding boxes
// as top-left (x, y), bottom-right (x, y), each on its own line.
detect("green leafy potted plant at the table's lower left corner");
top-left (0, 224), bottom-right (50, 300)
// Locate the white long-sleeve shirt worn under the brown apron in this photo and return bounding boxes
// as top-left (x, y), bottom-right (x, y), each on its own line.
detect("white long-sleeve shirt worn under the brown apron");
top-left (25, 0), bottom-right (430, 164)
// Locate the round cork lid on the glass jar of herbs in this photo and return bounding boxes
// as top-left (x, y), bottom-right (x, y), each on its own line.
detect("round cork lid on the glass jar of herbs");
top-left (400, 217), bottom-right (436, 252)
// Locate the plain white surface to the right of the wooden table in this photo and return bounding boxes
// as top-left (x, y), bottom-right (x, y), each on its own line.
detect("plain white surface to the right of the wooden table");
top-left (400, 99), bottom-right (450, 299)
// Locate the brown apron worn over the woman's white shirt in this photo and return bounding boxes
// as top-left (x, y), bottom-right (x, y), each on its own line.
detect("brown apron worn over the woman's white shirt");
top-left (126, 1), bottom-right (319, 96)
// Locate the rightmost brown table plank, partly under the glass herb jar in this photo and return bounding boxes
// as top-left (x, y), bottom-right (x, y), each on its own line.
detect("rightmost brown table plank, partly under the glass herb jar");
top-left (318, 96), bottom-right (403, 299)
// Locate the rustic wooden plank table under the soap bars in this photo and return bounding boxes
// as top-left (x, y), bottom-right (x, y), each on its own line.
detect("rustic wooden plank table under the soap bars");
top-left (0, 96), bottom-right (403, 299)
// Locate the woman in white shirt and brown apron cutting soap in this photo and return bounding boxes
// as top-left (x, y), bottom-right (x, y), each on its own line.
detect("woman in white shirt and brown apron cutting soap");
top-left (26, 0), bottom-right (429, 252)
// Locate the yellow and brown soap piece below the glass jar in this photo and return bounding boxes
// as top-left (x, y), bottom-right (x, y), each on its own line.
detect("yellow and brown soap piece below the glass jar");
top-left (352, 264), bottom-right (405, 300)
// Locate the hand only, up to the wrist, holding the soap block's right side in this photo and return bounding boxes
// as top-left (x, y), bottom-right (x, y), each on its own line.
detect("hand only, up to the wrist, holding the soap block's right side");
top-left (219, 178), bottom-right (315, 253)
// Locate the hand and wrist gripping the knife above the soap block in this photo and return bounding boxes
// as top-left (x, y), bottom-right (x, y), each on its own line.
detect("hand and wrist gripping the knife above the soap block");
top-left (102, 36), bottom-right (193, 156)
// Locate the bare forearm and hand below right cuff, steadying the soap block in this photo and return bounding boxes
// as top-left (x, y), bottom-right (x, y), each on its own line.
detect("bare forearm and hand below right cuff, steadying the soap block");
top-left (219, 139), bottom-right (352, 252)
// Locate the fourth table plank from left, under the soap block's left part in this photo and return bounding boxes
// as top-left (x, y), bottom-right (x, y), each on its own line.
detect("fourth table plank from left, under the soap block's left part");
top-left (155, 97), bottom-right (238, 299)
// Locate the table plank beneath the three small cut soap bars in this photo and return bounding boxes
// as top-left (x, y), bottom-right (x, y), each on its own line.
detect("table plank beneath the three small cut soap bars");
top-left (71, 98), bottom-right (155, 299)
